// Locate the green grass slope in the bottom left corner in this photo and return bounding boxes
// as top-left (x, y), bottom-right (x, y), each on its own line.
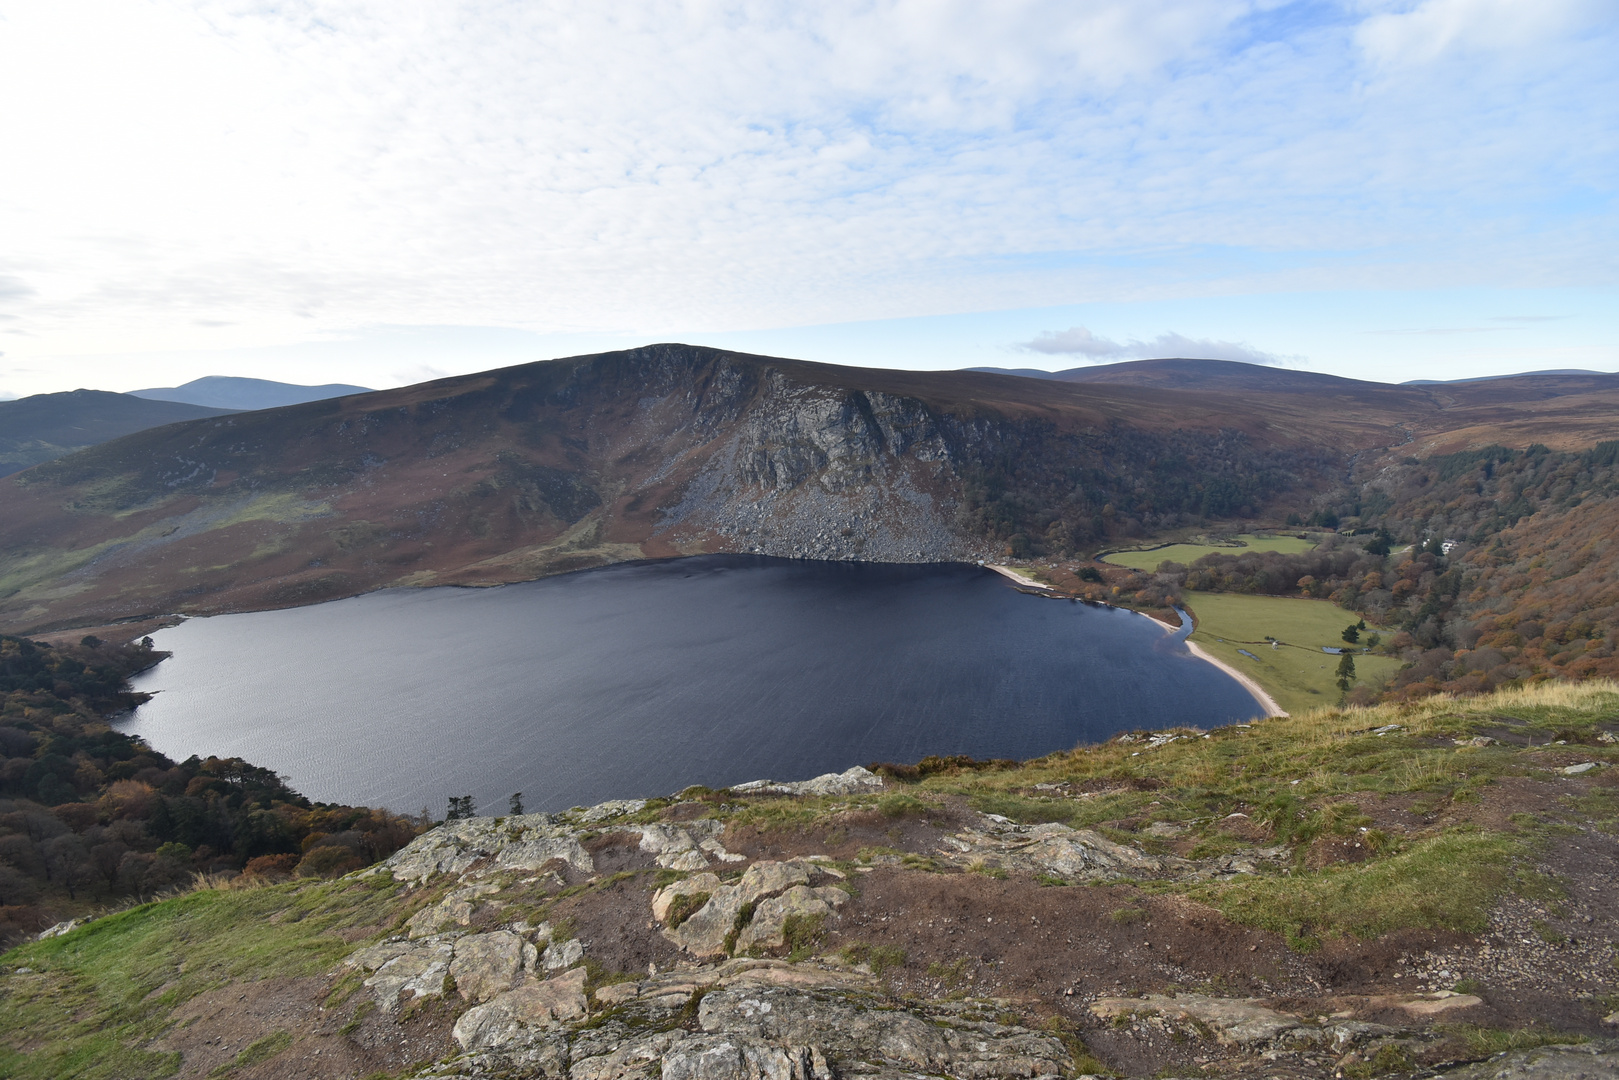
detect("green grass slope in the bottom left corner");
top-left (0, 878), bottom-right (403, 1080)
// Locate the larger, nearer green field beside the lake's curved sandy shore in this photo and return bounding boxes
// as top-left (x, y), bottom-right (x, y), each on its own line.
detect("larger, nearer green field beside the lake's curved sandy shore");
top-left (1183, 593), bottom-right (1400, 712)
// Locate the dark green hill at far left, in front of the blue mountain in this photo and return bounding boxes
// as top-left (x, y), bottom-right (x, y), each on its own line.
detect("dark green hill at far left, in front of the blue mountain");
top-left (0, 390), bottom-right (228, 476)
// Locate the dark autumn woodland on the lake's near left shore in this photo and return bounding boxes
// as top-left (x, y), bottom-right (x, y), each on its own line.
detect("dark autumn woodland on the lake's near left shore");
top-left (0, 636), bottom-right (427, 946)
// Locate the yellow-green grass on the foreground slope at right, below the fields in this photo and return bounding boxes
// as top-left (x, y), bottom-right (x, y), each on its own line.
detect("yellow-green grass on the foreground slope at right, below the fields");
top-left (916, 682), bottom-right (1619, 949)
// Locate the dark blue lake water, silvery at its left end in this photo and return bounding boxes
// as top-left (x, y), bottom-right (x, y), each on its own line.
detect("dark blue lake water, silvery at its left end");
top-left (120, 555), bottom-right (1261, 816)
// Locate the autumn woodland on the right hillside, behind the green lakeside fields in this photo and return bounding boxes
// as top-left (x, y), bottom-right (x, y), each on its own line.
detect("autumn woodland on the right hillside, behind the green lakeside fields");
top-left (1094, 442), bottom-right (1619, 703)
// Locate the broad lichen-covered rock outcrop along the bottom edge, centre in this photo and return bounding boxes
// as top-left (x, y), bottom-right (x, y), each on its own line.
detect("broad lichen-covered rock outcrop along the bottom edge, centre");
top-left (432, 960), bottom-right (1073, 1080)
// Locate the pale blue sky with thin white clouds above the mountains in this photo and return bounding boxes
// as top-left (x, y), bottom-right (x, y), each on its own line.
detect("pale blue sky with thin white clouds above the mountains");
top-left (0, 0), bottom-right (1619, 397)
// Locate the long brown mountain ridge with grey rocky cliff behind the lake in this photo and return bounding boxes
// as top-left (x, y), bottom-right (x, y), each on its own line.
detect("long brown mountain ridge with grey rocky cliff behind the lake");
top-left (0, 345), bottom-right (1619, 631)
